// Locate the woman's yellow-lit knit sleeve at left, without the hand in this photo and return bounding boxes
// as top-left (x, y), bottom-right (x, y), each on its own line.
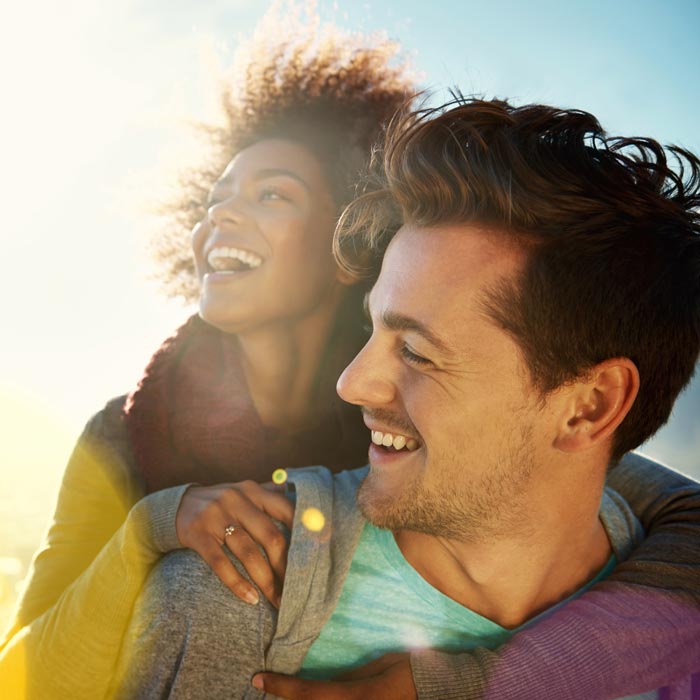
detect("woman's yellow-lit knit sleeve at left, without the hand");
top-left (0, 402), bottom-right (187, 700)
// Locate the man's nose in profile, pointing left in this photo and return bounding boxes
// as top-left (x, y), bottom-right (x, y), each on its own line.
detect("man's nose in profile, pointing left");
top-left (336, 338), bottom-right (396, 407)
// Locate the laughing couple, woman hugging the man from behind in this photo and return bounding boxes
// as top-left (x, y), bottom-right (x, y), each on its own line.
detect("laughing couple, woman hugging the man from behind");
top-left (0, 5), bottom-right (700, 700)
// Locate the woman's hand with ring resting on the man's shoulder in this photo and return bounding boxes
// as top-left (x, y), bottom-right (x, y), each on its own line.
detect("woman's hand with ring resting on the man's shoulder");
top-left (175, 481), bottom-right (294, 608)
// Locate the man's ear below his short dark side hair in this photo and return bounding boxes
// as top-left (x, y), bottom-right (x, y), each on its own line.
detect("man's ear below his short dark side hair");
top-left (554, 357), bottom-right (639, 452)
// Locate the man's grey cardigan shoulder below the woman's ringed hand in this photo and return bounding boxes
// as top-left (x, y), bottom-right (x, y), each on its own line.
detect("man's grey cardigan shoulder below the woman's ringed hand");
top-left (116, 549), bottom-right (276, 698)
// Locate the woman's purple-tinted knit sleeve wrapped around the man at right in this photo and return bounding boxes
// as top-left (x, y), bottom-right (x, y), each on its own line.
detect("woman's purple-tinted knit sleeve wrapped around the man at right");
top-left (411, 455), bottom-right (700, 700)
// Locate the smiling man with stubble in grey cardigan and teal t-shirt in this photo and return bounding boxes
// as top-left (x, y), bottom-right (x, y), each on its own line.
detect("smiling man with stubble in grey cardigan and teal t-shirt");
top-left (115, 100), bottom-right (700, 697)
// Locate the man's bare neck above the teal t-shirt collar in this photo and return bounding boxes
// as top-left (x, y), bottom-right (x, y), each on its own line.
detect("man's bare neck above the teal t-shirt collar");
top-left (394, 484), bottom-right (611, 629)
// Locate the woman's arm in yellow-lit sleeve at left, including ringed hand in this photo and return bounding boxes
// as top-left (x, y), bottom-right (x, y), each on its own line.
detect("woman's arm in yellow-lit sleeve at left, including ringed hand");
top-left (0, 400), bottom-right (294, 700)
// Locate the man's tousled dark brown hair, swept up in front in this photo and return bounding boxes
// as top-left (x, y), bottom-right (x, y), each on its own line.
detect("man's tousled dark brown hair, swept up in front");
top-left (335, 97), bottom-right (700, 461)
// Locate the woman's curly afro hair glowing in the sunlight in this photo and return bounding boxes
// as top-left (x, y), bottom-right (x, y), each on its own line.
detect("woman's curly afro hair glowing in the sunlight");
top-left (152, 3), bottom-right (415, 301)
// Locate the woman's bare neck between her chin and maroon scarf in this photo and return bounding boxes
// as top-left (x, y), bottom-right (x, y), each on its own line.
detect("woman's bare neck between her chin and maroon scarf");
top-left (239, 284), bottom-right (347, 433)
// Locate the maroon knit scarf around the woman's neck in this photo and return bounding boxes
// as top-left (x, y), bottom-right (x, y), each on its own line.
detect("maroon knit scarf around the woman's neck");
top-left (124, 294), bottom-right (369, 492)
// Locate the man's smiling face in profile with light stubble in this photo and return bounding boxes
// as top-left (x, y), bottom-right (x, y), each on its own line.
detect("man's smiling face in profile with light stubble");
top-left (338, 224), bottom-right (553, 540)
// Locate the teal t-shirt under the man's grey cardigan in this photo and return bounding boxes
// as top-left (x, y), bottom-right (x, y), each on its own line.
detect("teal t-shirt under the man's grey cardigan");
top-left (299, 523), bottom-right (615, 678)
